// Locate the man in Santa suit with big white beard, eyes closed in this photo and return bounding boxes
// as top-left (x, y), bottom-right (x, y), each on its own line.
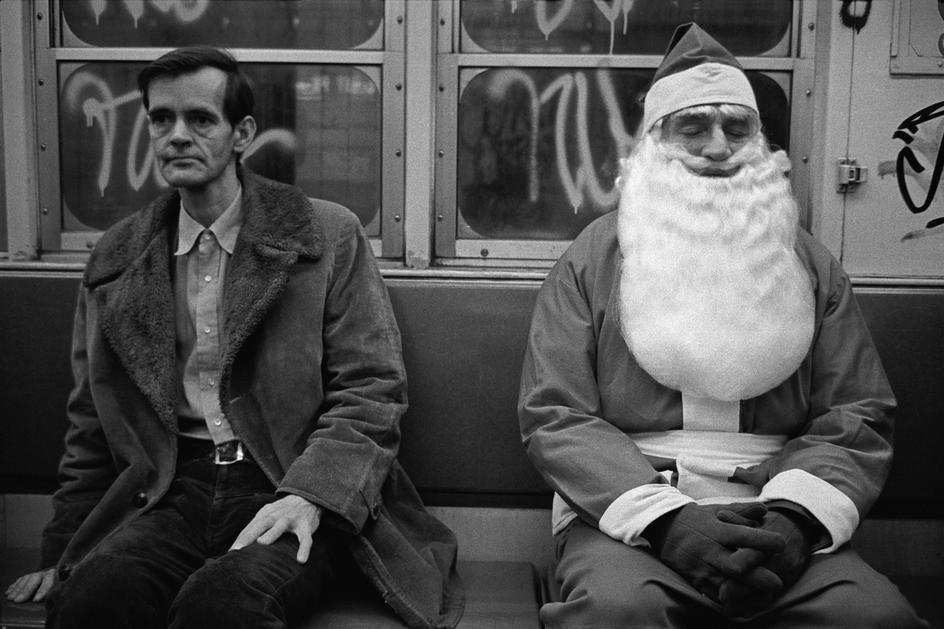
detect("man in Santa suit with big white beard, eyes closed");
top-left (519, 25), bottom-right (926, 629)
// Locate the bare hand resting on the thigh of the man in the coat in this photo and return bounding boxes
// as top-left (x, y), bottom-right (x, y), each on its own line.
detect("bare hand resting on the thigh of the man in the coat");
top-left (230, 494), bottom-right (321, 563)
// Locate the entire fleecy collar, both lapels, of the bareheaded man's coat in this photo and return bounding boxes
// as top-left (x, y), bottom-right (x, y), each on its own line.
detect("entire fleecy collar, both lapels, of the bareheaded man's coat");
top-left (84, 170), bottom-right (324, 432)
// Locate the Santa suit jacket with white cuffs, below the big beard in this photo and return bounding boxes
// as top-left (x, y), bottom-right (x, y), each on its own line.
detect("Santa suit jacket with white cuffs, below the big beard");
top-left (519, 212), bottom-right (895, 552)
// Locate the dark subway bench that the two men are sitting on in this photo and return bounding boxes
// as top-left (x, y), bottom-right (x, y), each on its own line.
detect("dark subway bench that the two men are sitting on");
top-left (0, 273), bottom-right (944, 629)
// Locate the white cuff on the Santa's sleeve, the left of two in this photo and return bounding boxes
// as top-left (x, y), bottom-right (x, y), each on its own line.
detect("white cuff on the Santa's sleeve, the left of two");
top-left (600, 483), bottom-right (695, 546)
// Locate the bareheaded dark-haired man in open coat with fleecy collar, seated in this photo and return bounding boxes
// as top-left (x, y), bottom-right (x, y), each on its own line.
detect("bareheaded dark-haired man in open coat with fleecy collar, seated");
top-left (7, 48), bottom-right (462, 629)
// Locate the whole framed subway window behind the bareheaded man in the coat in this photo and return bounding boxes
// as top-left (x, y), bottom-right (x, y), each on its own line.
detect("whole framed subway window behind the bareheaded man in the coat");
top-left (37, 0), bottom-right (403, 256)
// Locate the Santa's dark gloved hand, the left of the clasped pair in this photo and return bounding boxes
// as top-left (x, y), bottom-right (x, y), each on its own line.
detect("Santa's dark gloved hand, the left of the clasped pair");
top-left (643, 502), bottom-right (786, 604)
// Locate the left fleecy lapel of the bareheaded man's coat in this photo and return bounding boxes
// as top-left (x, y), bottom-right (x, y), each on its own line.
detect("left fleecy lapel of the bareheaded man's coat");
top-left (85, 193), bottom-right (180, 432)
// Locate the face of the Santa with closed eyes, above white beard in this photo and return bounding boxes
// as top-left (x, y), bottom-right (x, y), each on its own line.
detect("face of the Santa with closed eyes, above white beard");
top-left (662, 107), bottom-right (753, 177)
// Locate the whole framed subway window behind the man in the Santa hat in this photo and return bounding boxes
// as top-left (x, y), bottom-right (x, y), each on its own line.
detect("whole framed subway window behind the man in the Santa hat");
top-left (436, 0), bottom-right (799, 266)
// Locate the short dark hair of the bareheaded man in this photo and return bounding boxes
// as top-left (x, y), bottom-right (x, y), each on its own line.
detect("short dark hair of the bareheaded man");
top-left (138, 46), bottom-right (255, 127)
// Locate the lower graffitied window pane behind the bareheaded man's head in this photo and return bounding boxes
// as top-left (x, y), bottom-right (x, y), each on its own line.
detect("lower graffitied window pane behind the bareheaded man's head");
top-left (59, 62), bottom-right (381, 231)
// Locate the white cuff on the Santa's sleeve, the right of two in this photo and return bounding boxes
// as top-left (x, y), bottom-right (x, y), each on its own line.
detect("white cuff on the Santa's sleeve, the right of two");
top-left (760, 469), bottom-right (859, 553)
